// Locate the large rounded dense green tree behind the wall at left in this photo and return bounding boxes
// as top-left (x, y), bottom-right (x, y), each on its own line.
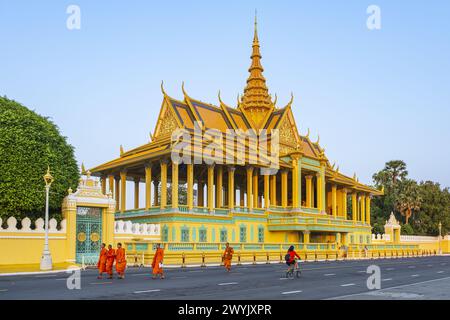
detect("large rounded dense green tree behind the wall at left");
top-left (0, 97), bottom-right (79, 219)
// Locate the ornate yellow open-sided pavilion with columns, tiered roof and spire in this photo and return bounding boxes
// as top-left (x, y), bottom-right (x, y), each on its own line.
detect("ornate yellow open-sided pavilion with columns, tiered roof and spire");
top-left (90, 18), bottom-right (382, 244)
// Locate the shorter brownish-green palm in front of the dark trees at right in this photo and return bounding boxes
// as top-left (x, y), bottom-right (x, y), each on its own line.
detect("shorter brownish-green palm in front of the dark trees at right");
top-left (396, 179), bottom-right (422, 224)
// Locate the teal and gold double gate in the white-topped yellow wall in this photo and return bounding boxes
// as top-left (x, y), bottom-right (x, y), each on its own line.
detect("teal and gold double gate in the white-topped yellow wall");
top-left (76, 207), bottom-right (102, 265)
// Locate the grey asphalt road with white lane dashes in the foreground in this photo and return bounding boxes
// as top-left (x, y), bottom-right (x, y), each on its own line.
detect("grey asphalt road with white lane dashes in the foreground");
top-left (0, 256), bottom-right (450, 300)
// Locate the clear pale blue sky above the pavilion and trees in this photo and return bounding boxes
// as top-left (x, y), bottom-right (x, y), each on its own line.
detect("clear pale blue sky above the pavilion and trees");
top-left (0, 0), bottom-right (450, 186)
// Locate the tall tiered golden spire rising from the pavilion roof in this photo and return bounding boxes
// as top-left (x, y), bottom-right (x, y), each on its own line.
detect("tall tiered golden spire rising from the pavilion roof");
top-left (241, 12), bottom-right (273, 125)
